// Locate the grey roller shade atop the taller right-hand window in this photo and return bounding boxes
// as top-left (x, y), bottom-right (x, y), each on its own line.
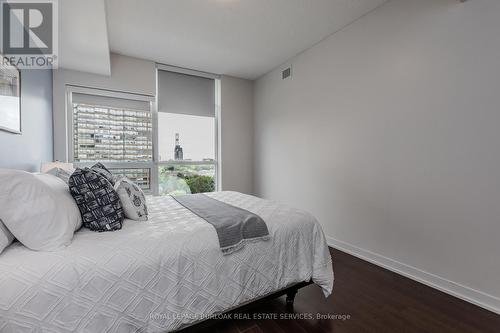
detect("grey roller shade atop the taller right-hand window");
top-left (158, 70), bottom-right (215, 117)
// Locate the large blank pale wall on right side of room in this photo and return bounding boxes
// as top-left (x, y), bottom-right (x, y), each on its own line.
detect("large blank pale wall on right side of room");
top-left (254, 0), bottom-right (500, 312)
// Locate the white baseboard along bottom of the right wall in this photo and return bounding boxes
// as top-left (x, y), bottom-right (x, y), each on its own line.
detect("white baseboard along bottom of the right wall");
top-left (326, 236), bottom-right (500, 314)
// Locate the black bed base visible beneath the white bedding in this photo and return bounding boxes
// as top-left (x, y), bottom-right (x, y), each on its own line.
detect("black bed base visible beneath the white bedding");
top-left (177, 281), bottom-right (313, 332)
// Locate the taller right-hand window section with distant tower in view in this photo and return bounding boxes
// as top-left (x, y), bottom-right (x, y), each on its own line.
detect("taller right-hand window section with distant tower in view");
top-left (158, 70), bottom-right (217, 194)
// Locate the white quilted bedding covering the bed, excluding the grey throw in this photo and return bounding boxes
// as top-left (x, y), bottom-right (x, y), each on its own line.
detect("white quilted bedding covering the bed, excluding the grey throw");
top-left (0, 192), bottom-right (333, 333)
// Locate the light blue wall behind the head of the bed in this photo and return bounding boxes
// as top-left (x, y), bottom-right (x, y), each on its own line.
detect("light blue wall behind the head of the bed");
top-left (0, 69), bottom-right (54, 171)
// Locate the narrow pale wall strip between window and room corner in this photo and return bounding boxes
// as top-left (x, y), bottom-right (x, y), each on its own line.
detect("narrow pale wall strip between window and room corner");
top-left (221, 76), bottom-right (253, 194)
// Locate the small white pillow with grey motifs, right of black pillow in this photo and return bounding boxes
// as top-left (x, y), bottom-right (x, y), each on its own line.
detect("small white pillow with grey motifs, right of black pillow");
top-left (115, 177), bottom-right (148, 221)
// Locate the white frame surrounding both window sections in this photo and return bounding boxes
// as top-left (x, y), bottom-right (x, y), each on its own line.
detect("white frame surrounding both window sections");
top-left (65, 64), bottom-right (222, 195)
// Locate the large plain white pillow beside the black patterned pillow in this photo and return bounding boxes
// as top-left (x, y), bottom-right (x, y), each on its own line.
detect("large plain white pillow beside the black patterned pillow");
top-left (0, 169), bottom-right (82, 251)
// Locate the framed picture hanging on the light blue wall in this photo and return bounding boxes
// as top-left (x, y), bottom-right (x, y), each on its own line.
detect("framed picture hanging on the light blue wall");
top-left (0, 59), bottom-right (21, 134)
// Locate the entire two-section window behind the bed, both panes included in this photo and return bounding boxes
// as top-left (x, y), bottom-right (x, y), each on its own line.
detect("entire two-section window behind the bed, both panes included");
top-left (67, 65), bottom-right (220, 195)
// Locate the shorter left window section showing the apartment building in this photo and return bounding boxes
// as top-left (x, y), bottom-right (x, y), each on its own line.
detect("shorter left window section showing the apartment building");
top-left (68, 87), bottom-right (153, 191)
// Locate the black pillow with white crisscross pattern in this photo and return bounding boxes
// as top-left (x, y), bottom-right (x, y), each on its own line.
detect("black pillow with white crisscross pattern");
top-left (68, 168), bottom-right (124, 231)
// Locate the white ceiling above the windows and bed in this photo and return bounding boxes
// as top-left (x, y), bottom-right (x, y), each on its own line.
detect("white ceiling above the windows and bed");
top-left (60, 0), bottom-right (386, 79)
